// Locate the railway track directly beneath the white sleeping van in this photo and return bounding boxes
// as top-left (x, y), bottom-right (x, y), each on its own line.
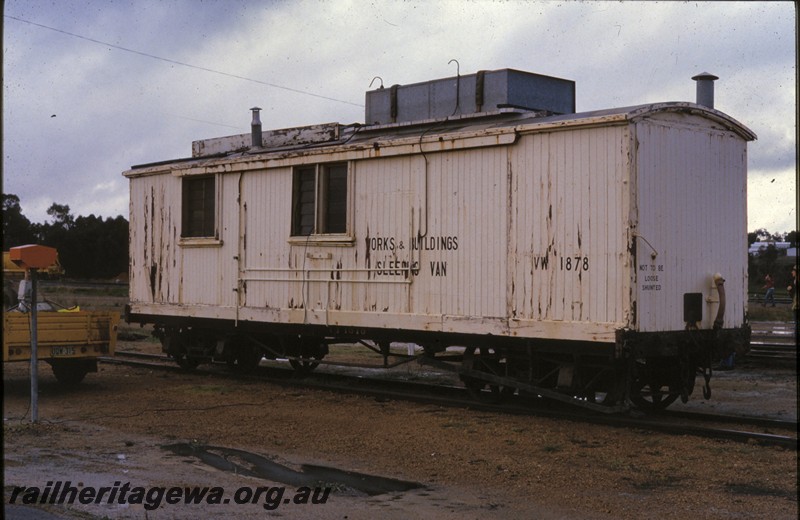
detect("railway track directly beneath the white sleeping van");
top-left (101, 352), bottom-right (797, 450)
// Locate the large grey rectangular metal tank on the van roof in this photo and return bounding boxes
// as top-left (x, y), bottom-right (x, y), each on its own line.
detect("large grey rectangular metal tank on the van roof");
top-left (365, 69), bottom-right (575, 124)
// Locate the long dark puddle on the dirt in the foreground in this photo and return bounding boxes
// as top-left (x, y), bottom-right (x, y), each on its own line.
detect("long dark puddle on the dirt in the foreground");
top-left (162, 443), bottom-right (423, 496)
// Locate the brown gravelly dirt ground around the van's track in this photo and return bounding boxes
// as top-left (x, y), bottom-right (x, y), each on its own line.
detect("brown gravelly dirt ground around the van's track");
top-left (3, 336), bottom-right (798, 520)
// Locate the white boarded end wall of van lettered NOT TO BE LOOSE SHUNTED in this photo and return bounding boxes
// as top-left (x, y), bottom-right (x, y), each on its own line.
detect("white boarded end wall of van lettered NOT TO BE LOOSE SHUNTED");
top-left (636, 117), bottom-right (747, 331)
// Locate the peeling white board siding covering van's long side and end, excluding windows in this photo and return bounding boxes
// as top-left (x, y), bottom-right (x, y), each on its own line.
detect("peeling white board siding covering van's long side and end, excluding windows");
top-left (126, 104), bottom-right (754, 342)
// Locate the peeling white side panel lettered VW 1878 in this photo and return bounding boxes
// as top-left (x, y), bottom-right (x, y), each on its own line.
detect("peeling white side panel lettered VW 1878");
top-left (510, 126), bottom-right (630, 334)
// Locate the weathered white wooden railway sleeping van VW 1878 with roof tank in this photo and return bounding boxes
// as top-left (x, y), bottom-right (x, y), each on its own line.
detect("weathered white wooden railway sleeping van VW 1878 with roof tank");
top-left (124, 69), bottom-right (756, 411)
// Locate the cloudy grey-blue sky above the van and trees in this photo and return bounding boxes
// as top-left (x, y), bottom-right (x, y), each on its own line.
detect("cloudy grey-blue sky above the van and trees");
top-left (3, 0), bottom-right (797, 232)
